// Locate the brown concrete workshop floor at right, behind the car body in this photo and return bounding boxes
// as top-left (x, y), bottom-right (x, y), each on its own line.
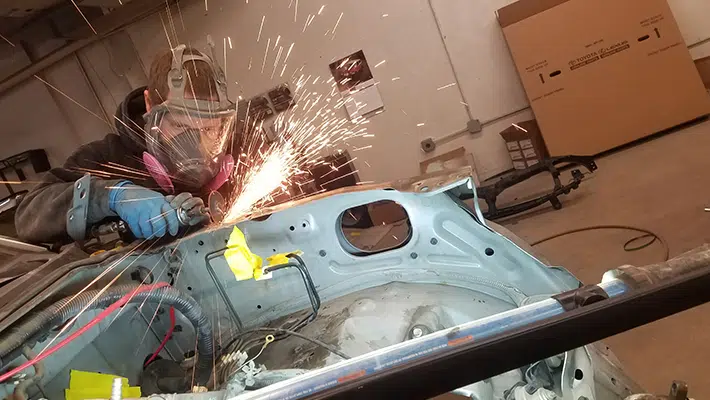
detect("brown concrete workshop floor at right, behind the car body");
top-left (498, 117), bottom-right (710, 399)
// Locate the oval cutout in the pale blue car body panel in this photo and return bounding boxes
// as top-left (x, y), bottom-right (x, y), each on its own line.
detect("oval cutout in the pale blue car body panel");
top-left (338, 200), bottom-right (412, 256)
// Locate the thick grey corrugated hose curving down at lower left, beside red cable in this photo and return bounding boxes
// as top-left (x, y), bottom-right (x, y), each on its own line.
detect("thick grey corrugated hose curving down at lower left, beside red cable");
top-left (0, 284), bottom-right (214, 385)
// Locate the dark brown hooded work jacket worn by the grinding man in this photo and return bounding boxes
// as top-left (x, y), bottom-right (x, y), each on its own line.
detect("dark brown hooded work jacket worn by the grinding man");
top-left (15, 87), bottom-right (258, 243)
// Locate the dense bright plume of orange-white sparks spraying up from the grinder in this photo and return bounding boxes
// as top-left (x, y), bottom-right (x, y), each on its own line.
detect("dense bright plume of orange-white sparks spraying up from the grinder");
top-left (223, 71), bottom-right (372, 224)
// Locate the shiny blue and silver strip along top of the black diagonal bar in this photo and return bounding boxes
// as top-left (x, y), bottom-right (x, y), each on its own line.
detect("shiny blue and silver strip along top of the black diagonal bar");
top-left (235, 279), bottom-right (629, 400)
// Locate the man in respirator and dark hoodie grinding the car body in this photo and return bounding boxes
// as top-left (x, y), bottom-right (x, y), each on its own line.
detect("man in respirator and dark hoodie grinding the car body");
top-left (15, 45), bottom-right (238, 243)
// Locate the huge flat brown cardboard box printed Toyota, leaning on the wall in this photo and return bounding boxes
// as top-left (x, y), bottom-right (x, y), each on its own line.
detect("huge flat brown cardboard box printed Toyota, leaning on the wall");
top-left (498, 0), bottom-right (710, 156)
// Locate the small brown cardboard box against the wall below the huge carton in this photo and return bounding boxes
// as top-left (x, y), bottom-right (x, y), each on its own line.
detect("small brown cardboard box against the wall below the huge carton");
top-left (500, 120), bottom-right (547, 169)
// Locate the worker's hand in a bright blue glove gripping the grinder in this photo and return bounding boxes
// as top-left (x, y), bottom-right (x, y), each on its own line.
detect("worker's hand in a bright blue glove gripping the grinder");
top-left (109, 181), bottom-right (180, 239)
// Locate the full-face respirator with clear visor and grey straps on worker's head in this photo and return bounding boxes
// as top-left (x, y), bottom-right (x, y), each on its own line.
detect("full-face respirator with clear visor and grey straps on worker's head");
top-left (143, 45), bottom-right (237, 193)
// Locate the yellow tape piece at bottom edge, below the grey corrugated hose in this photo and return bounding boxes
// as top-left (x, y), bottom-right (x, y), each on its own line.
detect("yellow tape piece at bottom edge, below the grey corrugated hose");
top-left (64, 370), bottom-right (141, 400)
